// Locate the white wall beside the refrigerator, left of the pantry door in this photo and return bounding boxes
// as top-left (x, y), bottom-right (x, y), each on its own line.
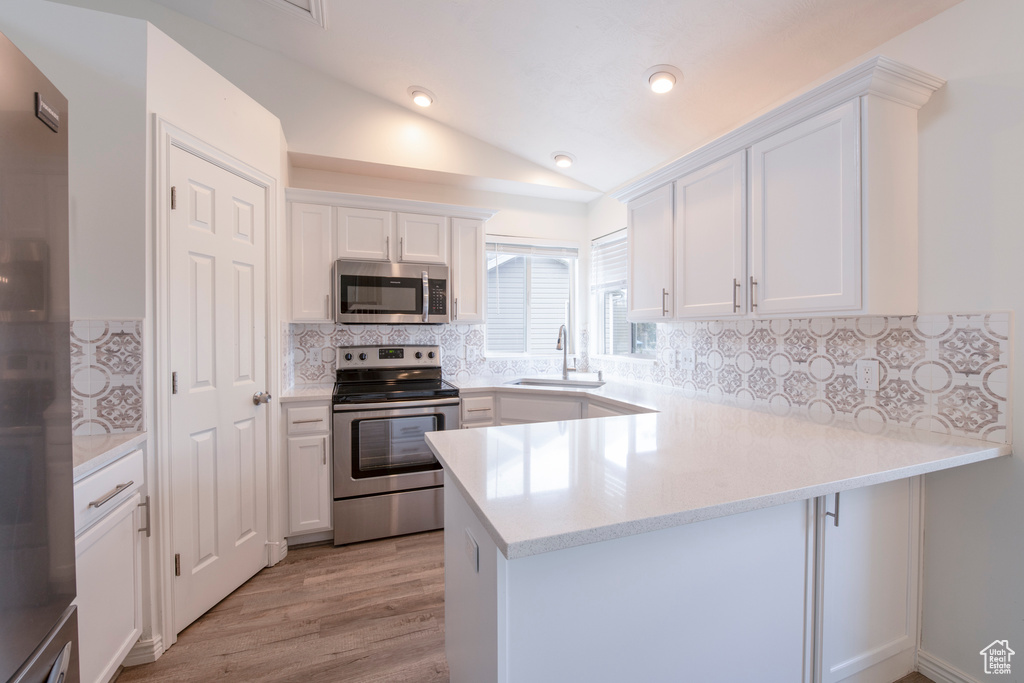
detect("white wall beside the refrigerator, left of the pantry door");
top-left (0, 0), bottom-right (147, 319)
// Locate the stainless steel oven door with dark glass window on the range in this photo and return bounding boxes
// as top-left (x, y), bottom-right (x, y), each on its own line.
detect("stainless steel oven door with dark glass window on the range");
top-left (334, 398), bottom-right (459, 499)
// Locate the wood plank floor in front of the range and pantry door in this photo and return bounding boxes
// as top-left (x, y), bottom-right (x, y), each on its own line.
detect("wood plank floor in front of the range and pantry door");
top-left (117, 531), bottom-right (932, 683)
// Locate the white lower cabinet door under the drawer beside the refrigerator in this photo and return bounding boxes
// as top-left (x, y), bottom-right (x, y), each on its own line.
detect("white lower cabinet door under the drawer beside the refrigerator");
top-left (75, 493), bottom-right (142, 683)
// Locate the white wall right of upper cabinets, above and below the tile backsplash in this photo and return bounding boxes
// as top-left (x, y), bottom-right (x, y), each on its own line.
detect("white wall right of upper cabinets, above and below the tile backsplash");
top-left (856, 0), bottom-right (1024, 680)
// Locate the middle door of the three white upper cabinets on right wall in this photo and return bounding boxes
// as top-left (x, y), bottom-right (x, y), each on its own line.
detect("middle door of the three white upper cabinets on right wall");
top-left (674, 152), bottom-right (746, 317)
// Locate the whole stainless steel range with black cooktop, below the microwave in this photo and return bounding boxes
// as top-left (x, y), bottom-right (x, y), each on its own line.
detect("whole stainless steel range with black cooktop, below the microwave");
top-left (334, 346), bottom-right (459, 545)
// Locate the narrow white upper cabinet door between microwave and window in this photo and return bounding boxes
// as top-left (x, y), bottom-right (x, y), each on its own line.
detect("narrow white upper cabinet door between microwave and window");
top-left (451, 218), bottom-right (487, 323)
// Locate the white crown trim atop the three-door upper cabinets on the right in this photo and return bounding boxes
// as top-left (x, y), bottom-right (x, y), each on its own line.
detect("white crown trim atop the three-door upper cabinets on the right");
top-left (609, 55), bottom-right (945, 203)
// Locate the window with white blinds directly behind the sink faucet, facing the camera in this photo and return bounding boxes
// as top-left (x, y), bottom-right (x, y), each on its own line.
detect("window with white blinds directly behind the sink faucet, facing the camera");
top-left (486, 241), bottom-right (578, 354)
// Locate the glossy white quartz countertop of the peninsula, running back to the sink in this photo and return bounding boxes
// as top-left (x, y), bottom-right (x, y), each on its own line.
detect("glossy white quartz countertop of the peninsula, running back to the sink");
top-left (427, 380), bottom-right (1012, 559)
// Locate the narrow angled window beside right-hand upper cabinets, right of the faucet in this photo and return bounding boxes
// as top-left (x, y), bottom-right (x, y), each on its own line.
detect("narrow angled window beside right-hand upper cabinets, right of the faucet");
top-left (590, 228), bottom-right (657, 358)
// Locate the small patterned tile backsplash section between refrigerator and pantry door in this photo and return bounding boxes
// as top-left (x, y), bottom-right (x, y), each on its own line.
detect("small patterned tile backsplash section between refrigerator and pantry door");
top-left (71, 321), bottom-right (144, 435)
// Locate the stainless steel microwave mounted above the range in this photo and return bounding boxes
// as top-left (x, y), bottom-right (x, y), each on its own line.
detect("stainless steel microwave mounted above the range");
top-left (333, 259), bottom-right (451, 325)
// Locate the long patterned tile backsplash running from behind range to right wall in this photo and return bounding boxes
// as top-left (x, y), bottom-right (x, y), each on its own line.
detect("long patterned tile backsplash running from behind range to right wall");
top-left (284, 312), bottom-right (1012, 442)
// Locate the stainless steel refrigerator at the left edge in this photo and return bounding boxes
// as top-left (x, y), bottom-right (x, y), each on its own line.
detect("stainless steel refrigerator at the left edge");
top-left (0, 28), bottom-right (79, 683)
